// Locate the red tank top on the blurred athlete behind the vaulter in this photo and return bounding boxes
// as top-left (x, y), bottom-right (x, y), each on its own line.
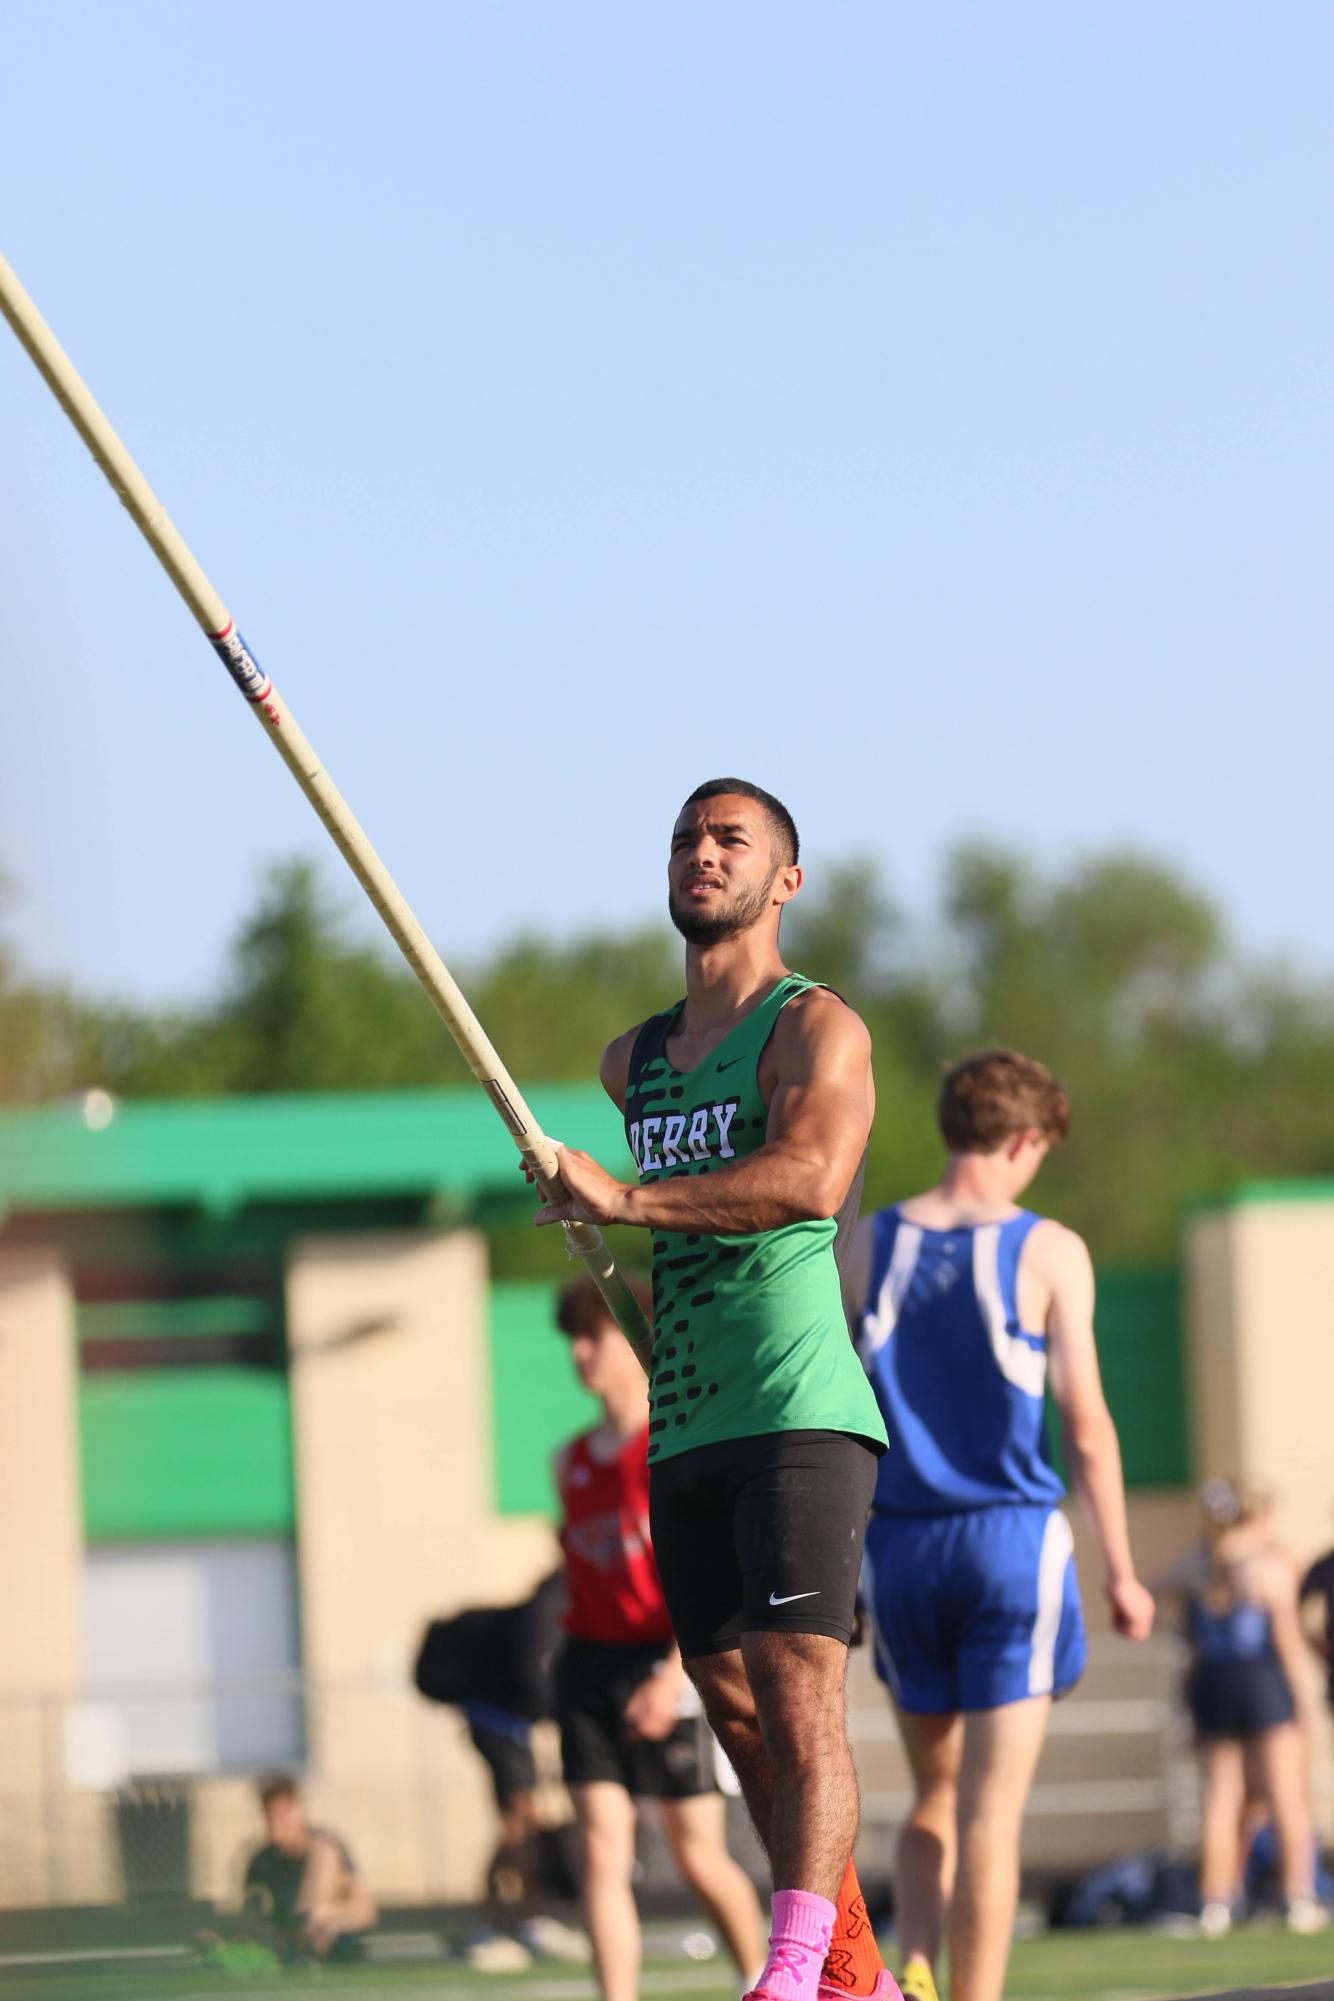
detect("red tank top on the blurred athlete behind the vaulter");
top-left (558, 1425), bottom-right (672, 1647)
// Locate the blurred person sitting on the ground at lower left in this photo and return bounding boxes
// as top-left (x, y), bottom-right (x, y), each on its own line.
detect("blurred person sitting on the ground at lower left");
top-left (244, 1777), bottom-right (378, 1961)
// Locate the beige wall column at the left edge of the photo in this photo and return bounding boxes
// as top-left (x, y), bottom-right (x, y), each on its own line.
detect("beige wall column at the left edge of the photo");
top-left (0, 1247), bottom-right (84, 1905)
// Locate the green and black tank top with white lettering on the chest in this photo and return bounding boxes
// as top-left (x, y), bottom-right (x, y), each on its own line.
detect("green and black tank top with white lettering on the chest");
top-left (626, 972), bottom-right (886, 1461)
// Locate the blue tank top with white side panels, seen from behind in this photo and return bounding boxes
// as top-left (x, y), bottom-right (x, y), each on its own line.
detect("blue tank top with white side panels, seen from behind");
top-left (858, 1209), bottom-right (1064, 1515)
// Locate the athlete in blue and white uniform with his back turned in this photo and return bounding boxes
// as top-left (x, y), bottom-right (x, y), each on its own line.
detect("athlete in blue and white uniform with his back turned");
top-left (848, 1049), bottom-right (1154, 2001)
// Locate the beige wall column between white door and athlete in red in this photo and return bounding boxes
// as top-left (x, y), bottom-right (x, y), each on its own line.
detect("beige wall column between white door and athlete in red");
top-left (288, 1233), bottom-right (554, 1897)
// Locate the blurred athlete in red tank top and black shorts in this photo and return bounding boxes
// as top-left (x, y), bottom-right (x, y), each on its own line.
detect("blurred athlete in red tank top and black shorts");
top-left (556, 1277), bottom-right (764, 2001)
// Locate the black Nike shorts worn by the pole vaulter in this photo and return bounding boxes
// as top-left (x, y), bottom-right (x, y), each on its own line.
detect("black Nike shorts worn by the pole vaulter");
top-left (648, 1431), bottom-right (878, 1659)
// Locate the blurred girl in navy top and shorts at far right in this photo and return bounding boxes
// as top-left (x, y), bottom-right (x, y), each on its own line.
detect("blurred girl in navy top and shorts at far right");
top-left (1162, 1481), bottom-right (1328, 1937)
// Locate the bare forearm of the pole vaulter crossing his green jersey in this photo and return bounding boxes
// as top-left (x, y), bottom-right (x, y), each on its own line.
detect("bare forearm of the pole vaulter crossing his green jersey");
top-left (618, 1141), bottom-right (848, 1237)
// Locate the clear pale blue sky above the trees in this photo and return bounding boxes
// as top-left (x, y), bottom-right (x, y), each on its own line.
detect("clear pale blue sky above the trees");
top-left (0, 0), bottom-right (1334, 998)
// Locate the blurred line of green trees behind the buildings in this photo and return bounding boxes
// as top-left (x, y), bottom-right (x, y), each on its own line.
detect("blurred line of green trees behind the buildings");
top-left (0, 844), bottom-right (1334, 1269)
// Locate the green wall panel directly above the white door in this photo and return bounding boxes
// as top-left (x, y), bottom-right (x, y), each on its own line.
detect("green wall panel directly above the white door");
top-left (78, 1369), bottom-right (294, 1543)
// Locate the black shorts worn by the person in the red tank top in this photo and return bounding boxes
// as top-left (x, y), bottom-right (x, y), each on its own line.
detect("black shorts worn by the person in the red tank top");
top-left (556, 1637), bottom-right (718, 1799)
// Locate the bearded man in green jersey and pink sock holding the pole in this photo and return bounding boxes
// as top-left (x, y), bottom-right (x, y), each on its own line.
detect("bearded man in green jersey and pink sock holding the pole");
top-left (538, 778), bottom-right (898, 2001)
